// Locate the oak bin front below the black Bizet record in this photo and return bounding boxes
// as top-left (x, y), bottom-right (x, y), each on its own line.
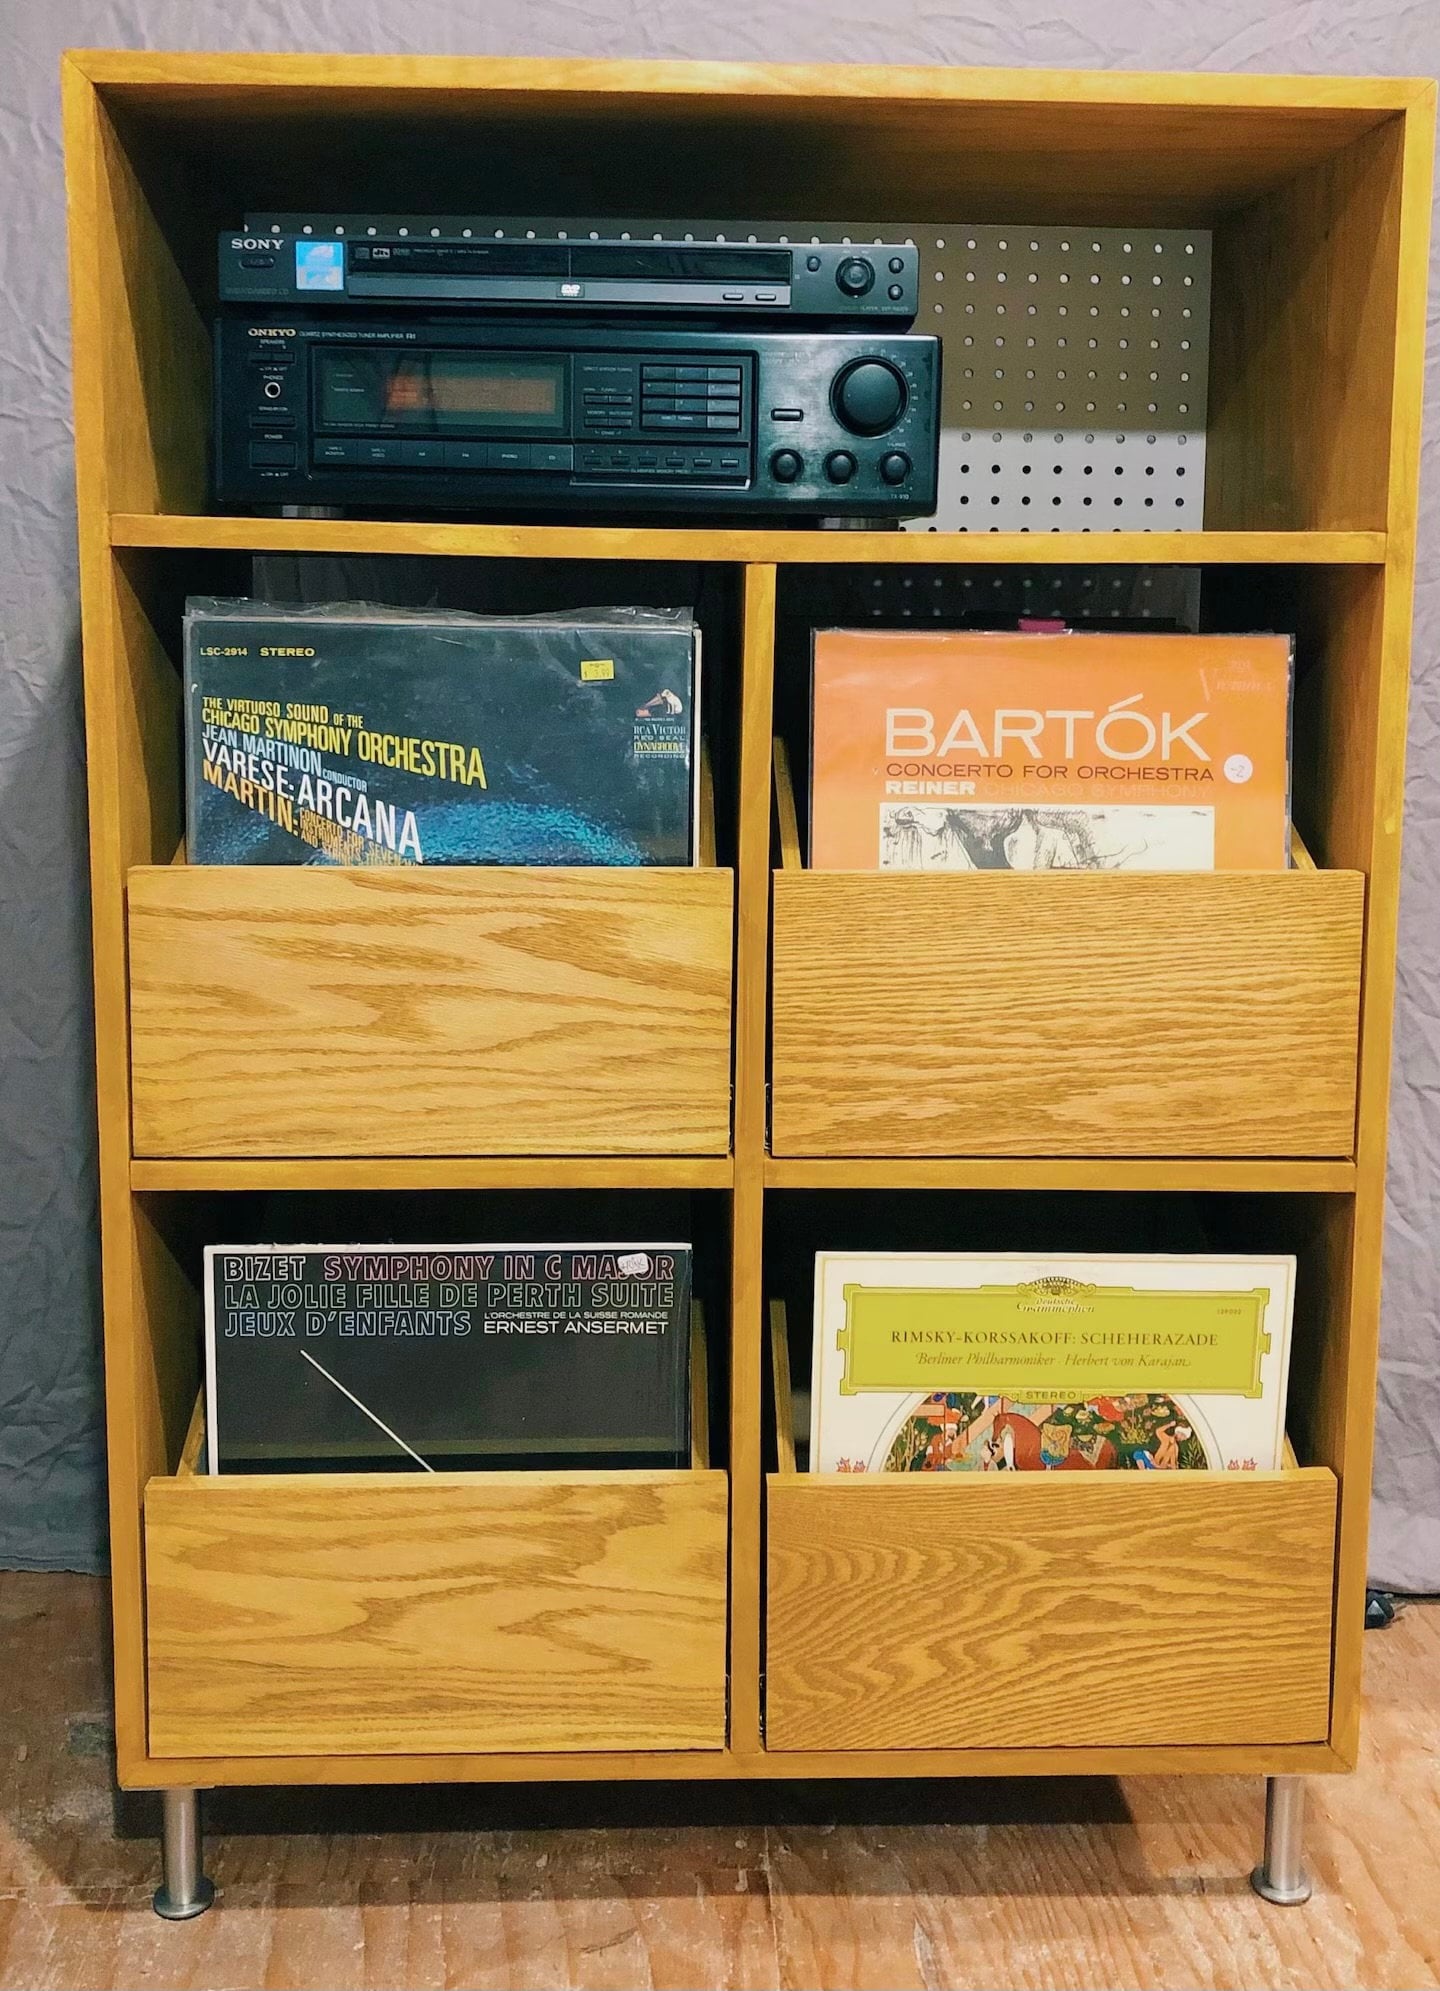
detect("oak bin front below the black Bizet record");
top-left (145, 1471), bottom-right (727, 1756)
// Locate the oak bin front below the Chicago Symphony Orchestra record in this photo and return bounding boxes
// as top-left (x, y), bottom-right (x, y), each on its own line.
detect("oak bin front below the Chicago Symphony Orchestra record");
top-left (129, 864), bottom-right (733, 1157)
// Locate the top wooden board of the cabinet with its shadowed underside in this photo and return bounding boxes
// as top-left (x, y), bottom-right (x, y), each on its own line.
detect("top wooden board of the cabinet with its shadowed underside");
top-left (70, 50), bottom-right (1430, 225)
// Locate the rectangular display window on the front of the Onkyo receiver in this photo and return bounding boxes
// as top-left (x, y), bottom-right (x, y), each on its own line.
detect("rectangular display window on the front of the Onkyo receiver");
top-left (317, 348), bottom-right (566, 436)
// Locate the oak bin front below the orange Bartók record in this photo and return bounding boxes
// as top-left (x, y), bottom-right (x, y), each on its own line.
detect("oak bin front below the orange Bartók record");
top-left (773, 870), bottom-right (1364, 1157)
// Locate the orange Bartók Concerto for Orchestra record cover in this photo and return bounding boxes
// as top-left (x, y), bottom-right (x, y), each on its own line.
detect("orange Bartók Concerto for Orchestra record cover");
top-left (811, 629), bottom-right (1295, 870)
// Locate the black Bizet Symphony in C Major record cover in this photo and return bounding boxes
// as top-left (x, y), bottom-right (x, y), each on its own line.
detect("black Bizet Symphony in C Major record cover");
top-left (205, 1244), bottom-right (691, 1473)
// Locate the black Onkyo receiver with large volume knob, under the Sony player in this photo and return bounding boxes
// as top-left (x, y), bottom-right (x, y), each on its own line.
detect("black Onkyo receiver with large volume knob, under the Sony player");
top-left (215, 318), bottom-right (940, 518)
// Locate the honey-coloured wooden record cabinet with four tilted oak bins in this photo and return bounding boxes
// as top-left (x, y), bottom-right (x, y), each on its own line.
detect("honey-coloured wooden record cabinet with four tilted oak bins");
top-left (64, 52), bottom-right (1434, 1788)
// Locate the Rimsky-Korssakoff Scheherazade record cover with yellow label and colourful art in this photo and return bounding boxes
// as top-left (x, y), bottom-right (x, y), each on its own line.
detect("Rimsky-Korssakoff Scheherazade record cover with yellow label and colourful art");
top-left (811, 1252), bottom-right (1295, 1473)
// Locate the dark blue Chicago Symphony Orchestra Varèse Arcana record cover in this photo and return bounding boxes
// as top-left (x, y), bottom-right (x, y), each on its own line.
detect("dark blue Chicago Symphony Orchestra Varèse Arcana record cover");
top-left (185, 599), bottom-right (699, 864)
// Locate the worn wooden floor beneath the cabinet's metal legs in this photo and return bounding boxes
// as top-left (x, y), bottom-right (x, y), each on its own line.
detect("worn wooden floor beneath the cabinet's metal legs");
top-left (0, 1575), bottom-right (1440, 1991)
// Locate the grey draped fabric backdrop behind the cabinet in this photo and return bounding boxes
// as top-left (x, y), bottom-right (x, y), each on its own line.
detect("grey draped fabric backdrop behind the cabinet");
top-left (0, 0), bottom-right (1440, 1591)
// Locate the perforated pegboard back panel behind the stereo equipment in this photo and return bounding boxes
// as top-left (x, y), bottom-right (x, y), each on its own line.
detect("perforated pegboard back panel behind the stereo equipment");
top-left (264, 213), bottom-right (1211, 532)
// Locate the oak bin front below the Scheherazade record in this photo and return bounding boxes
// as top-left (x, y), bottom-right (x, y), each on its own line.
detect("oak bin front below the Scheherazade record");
top-left (765, 1467), bottom-right (1336, 1750)
